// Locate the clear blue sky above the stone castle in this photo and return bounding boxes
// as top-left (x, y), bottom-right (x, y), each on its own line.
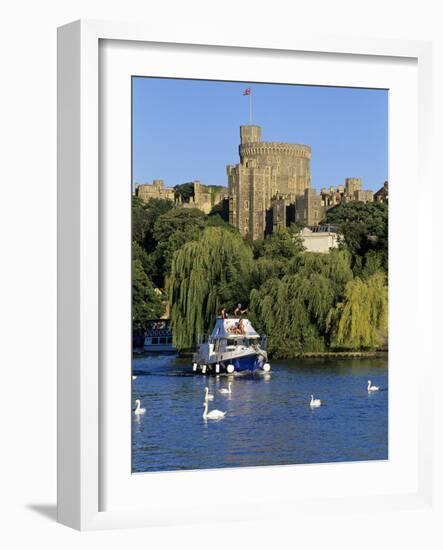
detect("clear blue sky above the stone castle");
top-left (133, 77), bottom-right (388, 190)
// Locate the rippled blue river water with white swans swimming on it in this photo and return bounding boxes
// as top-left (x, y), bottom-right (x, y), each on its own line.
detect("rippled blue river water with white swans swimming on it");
top-left (132, 355), bottom-right (388, 472)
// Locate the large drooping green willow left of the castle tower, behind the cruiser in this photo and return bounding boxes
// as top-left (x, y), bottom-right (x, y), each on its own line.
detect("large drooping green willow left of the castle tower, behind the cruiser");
top-left (167, 227), bottom-right (253, 349)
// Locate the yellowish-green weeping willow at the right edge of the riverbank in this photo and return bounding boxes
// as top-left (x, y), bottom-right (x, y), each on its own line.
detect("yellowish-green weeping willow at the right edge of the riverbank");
top-left (326, 271), bottom-right (388, 349)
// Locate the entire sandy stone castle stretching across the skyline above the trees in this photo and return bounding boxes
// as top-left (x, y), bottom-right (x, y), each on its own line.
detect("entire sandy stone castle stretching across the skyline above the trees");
top-left (135, 125), bottom-right (388, 240)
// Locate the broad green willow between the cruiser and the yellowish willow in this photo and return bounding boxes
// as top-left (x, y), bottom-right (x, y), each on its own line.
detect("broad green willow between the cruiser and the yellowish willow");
top-left (250, 250), bottom-right (352, 357)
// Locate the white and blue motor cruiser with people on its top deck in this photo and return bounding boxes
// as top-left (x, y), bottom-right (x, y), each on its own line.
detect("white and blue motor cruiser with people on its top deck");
top-left (192, 318), bottom-right (271, 374)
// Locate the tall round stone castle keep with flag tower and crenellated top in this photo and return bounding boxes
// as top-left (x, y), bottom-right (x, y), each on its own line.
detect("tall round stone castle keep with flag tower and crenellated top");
top-left (227, 125), bottom-right (311, 240)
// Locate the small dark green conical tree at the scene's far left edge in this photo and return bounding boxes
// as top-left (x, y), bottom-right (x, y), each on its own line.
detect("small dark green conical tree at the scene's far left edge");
top-left (132, 260), bottom-right (164, 327)
